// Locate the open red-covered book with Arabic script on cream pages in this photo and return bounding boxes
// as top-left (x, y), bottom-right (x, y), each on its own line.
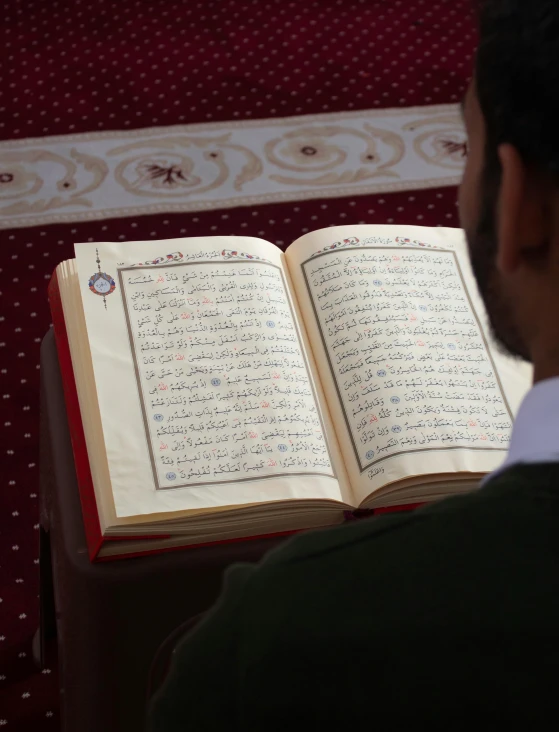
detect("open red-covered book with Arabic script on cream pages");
top-left (50, 226), bottom-right (531, 559)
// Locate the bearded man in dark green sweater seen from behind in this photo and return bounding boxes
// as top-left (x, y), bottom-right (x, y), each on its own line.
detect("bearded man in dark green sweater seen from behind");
top-left (151, 0), bottom-right (559, 732)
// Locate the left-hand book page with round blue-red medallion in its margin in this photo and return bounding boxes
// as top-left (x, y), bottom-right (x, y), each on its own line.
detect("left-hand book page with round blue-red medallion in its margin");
top-left (76, 237), bottom-right (349, 517)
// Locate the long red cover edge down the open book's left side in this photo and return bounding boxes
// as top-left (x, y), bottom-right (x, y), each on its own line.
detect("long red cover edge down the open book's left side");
top-left (48, 271), bottom-right (103, 561)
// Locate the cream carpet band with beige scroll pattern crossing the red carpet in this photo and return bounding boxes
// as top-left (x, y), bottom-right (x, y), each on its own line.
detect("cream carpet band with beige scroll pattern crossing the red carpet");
top-left (0, 105), bottom-right (466, 228)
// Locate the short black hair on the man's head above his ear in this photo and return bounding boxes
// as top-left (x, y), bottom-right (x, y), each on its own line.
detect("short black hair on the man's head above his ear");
top-left (475, 0), bottom-right (559, 178)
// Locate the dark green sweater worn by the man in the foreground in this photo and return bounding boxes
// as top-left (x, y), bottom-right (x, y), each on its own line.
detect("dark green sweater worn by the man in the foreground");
top-left (150, 463), bottom-right (559, 732)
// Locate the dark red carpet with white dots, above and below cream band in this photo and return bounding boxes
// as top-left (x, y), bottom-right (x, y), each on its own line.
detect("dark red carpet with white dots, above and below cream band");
top-left (0, 0), bottom-right (475, 732)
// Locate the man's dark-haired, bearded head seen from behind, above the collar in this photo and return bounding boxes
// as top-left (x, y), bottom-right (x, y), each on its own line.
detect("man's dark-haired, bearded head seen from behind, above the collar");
top-left (459, 0), bottom-right (559, 380)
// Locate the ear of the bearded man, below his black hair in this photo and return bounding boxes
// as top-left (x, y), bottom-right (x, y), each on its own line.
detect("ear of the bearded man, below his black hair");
top-left (497, 143), bottom-right (543, 275)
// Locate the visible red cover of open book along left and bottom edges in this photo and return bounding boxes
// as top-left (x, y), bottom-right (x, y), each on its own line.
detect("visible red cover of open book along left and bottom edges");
top-left (48, 270), bottom-right (423, 562)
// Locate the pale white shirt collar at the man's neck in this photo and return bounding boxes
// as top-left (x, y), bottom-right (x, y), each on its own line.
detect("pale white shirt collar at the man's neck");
top-left (482, 377), bottom-right (559, 485)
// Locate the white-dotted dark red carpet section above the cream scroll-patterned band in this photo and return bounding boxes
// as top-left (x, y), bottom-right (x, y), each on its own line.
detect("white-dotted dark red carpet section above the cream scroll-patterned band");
top-left (0, 0), bottom-right (475, 138)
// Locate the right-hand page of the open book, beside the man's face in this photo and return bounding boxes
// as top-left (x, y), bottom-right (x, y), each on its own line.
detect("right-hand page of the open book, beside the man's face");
top-left (286, 226), bottom-right (531, 501)
